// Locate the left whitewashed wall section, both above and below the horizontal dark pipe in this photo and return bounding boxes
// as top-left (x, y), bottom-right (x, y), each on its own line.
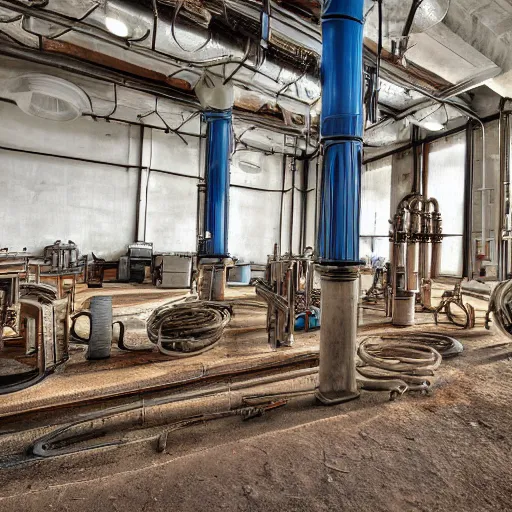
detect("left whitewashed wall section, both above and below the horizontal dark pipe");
top-left (0, 103), bottom-right (139, 258)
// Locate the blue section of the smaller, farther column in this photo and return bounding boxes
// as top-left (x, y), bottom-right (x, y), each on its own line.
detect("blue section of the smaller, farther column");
top-left (203, 110), bottom-right (232, 257)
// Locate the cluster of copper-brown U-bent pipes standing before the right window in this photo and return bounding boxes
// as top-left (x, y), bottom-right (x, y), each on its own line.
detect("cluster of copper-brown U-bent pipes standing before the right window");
top-left (386, 193), bottom-right (443, 326)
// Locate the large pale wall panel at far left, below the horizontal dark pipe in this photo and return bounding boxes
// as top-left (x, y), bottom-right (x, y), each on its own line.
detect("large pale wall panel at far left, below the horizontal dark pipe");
top-left (0, 151), bottom-right (138, 258)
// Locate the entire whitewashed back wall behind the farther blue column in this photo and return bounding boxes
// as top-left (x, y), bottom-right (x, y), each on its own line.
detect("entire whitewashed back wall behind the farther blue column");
top-left (0, 103), bottom-right (300, 263)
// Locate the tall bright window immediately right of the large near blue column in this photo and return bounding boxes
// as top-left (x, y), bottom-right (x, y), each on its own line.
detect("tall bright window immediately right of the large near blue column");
top-left (359, 157), bottom-right (391, 260)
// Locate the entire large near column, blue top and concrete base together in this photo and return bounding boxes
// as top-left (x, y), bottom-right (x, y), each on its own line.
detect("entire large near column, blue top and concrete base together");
top-left (317, 0), bottom-right (364, 405)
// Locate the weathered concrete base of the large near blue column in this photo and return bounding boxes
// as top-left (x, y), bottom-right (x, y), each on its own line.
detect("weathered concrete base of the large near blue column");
top-left (316, 265), bottom-right (359, 405)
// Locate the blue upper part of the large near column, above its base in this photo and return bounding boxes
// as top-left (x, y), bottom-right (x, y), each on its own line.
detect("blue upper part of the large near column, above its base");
top-left (318, 0), bottom-right (364, 265)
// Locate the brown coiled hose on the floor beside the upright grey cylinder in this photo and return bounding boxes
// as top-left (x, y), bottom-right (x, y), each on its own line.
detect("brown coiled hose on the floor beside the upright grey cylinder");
top-left (146, 301), bottom-right (233, 357)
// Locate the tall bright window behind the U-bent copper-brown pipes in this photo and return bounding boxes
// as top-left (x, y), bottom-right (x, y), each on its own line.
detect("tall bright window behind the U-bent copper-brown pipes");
top-left (427, 133), bottom-right (466, 277)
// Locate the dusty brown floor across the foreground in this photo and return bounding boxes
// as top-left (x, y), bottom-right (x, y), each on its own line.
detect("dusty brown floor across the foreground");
top-left (0, 284), bottom-right (512, 512)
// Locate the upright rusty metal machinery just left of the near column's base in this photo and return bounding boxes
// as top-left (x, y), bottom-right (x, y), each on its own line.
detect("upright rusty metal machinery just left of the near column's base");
top-left (256, 244), bottom-right (320, 350)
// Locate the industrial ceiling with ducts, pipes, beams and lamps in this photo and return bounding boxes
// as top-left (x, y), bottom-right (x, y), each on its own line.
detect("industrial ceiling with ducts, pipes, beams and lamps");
top-left (0, 0), bottom-right (512, 154)
